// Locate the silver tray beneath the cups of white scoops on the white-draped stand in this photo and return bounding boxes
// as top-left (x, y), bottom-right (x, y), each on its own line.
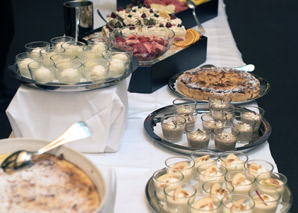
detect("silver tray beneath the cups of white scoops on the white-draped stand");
top-left (8, 57), bottom-right (139, 92)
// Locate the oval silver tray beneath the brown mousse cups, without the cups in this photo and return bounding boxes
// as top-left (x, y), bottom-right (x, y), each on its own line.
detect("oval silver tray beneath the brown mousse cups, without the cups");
top-left (144, 103), bottom-right (271, 154)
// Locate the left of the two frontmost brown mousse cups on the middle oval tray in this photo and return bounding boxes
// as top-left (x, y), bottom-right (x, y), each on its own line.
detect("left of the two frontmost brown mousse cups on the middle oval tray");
top-left (185, 122), bottom-right (212, 149)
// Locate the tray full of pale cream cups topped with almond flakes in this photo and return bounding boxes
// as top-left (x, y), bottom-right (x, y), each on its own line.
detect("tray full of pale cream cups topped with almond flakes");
top-left (145, 150), bottom-right (293, 213)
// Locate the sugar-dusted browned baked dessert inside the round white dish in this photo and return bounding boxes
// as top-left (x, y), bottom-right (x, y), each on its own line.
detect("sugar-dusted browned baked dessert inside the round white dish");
top-left (0, 154), bottom-right (101, 213)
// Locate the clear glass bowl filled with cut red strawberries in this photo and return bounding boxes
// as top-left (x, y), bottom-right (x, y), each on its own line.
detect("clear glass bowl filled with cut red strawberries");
top-left (110, 25), bottom-right (175, 65)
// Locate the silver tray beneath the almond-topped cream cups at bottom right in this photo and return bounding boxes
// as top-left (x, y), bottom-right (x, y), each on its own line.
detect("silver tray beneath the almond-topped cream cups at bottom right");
top-left (145, 177), bottom-right (293, 213)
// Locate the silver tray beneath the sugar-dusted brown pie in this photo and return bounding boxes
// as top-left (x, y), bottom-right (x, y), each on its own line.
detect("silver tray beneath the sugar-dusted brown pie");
top-left (168, 72), bottom-right (270, 104)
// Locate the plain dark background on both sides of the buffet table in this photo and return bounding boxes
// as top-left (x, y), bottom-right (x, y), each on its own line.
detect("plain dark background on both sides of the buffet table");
top-left (0, 0), bottom-right (298, 212)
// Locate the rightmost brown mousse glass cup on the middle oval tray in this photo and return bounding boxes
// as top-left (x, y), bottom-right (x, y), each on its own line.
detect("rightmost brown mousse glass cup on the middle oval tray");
top-left (240, 106), bottom-right (265, 132)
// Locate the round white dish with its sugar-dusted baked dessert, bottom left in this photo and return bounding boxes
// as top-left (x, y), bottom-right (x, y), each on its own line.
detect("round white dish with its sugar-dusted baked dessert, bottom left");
top-left (0, 138), bottom-right (107, 212)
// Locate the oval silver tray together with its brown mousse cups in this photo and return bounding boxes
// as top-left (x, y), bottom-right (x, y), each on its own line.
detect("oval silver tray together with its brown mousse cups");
top-left (144, 96), bottom-right (271, 154)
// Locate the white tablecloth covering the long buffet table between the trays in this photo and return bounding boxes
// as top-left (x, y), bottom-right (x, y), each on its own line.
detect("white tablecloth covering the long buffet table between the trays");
top-left (6, 0), bottom-right (277, 213)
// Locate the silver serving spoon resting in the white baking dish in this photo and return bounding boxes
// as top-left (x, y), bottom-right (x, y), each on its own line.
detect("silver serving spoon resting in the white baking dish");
top-left (1, 121), bottom-right (91, 171)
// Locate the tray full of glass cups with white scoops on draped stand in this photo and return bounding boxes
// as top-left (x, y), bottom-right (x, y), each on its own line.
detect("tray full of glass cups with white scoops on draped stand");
top-left (8, 36), bottom-right (139, 92)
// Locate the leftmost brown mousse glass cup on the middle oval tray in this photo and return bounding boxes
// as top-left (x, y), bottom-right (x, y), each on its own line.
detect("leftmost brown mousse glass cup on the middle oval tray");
top-left (161, 115), bottom-right (186, 142)
